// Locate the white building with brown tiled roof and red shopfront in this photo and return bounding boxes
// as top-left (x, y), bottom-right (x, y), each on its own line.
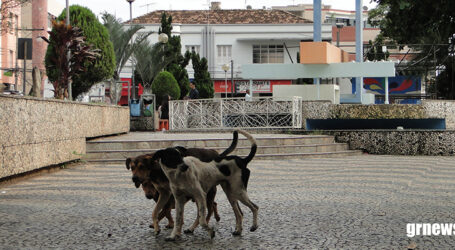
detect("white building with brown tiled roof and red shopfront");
top-left (120, 3), bottom-right (332, 96)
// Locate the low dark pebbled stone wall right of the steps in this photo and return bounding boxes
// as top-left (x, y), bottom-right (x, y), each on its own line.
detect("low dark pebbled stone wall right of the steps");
top-left (324, 130), bottom-right (455, 156)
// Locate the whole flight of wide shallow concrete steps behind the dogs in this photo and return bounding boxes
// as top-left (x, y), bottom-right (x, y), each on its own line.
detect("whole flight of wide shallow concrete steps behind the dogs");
top-left (84, 133), bottom-right (362, 164)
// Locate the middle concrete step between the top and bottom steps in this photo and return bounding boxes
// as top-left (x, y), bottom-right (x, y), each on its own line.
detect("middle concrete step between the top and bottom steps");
top-left (85, 143), bottom-right (349, 161)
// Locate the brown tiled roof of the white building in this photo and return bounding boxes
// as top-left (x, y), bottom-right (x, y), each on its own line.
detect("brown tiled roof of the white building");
top-left (133, 9), bottom-right (313, 24)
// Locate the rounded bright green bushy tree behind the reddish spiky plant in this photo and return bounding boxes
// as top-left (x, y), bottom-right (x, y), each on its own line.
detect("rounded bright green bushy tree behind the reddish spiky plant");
top-left (46, 5), bottom-right (115, 97)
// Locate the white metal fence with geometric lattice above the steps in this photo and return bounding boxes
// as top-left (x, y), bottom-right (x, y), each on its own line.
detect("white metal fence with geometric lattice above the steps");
top-left (169, 97), bottom-right (302, 130)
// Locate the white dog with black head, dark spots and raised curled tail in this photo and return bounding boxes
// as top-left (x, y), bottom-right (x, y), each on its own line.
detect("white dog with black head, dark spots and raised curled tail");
top-left (154, 131), bottom-right (259, 240)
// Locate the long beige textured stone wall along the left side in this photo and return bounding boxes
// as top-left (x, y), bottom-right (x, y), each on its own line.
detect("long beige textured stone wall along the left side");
top-left (0, 95), bottom-right (130, 179)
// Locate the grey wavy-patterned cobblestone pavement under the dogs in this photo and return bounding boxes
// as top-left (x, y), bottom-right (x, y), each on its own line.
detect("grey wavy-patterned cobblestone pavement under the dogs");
top-left (0, 155), bottom-right (455, 249)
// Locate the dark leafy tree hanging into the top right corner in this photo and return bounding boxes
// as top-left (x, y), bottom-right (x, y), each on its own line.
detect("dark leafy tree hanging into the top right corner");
top-left (369, 0), bottom-right (455, 98)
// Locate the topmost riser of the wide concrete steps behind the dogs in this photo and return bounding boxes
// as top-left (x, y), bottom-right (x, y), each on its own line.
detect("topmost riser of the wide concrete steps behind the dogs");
top-left (87, 135), bottom-right (335, 152)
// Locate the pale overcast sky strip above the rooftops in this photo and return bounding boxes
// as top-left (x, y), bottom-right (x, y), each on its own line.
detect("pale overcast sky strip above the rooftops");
top-left (57, 0), bottom-right (375, 21)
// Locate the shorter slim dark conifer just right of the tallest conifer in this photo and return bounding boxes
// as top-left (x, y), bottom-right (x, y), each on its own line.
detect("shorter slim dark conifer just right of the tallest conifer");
top-left (191, 53), bottom-right (214, 98)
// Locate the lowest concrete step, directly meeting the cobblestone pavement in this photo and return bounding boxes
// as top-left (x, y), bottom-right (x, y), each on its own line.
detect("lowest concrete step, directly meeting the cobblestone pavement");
top-left (86, 150), bottom-right (363, 164)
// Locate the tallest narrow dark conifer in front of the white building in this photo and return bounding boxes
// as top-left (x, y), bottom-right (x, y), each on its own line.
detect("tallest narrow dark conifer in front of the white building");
top-left (158, 12), bottom-right (190, 99)
